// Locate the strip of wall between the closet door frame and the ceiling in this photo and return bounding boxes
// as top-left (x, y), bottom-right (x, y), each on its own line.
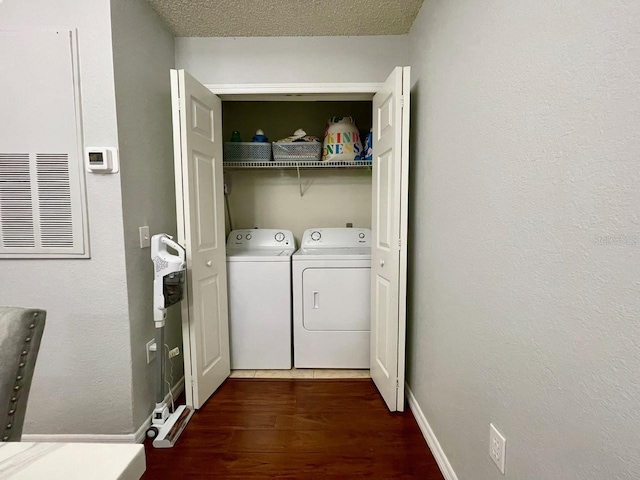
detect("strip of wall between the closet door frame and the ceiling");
top-left (176, 35), bottom-right (408, 83)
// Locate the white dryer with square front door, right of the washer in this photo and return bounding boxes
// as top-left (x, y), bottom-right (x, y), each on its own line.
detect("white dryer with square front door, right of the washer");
top-left (292, 228), bottom-right (371, 368)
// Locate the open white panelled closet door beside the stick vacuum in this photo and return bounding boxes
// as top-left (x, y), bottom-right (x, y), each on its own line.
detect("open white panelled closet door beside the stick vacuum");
top-left (171, 70), bottom-right (230, 408)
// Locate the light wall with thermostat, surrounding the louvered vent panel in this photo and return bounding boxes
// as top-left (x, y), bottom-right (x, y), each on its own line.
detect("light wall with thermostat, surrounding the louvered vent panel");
top-left (0, 0), bottom-right (133, 434)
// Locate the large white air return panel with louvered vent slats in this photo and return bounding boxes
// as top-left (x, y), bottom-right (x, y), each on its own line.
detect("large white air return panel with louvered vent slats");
top-left (0, 28), bottom-right (89, 259)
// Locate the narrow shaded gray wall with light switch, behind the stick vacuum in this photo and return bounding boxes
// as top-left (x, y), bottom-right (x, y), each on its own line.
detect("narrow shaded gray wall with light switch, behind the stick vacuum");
top-left (111, 0), bottom-right (183, 428)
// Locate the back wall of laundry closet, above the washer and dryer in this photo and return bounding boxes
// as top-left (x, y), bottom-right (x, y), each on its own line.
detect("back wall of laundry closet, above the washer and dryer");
top-left (222, 99), bottom-right (372, 240)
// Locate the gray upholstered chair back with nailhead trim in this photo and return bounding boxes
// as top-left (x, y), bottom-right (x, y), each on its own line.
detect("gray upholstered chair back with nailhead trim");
top-left (0, 307), bottom-right (47, 442)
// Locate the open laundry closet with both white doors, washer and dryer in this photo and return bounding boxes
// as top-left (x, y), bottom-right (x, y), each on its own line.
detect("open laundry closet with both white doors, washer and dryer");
top-left (172, 67), bottom-right (409, 410)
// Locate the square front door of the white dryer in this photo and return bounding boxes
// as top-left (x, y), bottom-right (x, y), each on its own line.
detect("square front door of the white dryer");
top-left (302, 267), bottom-right (371, 332)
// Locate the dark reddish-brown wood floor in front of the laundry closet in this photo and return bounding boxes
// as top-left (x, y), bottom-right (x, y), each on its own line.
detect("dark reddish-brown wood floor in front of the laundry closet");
top-left (143, 379), bottom-right (443, 480)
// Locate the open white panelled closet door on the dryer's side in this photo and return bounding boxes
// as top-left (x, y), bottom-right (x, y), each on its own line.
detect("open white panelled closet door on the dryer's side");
top-left (371, 67), bottom-right (410, 412)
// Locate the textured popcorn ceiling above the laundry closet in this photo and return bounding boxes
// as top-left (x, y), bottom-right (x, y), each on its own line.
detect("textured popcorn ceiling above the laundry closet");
top-left (148, 0), bottom-right (423, 37)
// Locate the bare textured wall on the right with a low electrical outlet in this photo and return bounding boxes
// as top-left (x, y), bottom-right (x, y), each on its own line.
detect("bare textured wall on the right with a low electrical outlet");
top-left (408, 0), bottom-right (640, 480)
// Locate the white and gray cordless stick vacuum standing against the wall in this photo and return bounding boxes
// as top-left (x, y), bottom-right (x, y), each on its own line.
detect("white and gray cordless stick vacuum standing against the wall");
top-left (147, 233), bottom-right (193, 448)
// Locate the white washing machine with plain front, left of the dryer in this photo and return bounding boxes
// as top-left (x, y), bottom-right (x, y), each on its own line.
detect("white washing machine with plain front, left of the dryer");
top-left (227, 229), bottom-right (295, 370)
